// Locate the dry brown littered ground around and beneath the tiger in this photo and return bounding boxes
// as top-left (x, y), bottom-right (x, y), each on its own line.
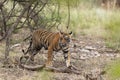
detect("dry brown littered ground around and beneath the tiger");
top-left (0, 36), bottom-right (120, 80)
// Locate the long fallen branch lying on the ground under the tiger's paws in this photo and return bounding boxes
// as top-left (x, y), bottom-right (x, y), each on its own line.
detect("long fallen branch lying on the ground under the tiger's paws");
top-left (19, 63), bottom-right (82, 74)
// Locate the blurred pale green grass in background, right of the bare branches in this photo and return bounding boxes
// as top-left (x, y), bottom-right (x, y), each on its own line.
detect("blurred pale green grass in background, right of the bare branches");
top-left (60, 0), bottom-right (120, 50)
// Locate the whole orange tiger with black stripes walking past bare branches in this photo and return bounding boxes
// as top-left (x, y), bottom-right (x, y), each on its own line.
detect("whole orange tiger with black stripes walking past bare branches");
top-left (22, 29), bottom-right (72, 67)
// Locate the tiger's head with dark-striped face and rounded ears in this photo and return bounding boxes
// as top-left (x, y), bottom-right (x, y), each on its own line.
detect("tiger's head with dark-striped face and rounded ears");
top-left (59, 31), bottom-right (72, 51)
